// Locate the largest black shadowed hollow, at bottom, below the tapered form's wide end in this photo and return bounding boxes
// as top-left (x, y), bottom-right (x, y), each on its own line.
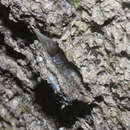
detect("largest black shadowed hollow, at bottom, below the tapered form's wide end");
top-left (34, 81), bottom-right (95, 128)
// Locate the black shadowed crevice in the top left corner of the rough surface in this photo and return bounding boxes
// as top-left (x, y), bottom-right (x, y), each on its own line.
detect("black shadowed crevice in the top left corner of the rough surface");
top-left (0, 5), bottom-right (34, 46)
